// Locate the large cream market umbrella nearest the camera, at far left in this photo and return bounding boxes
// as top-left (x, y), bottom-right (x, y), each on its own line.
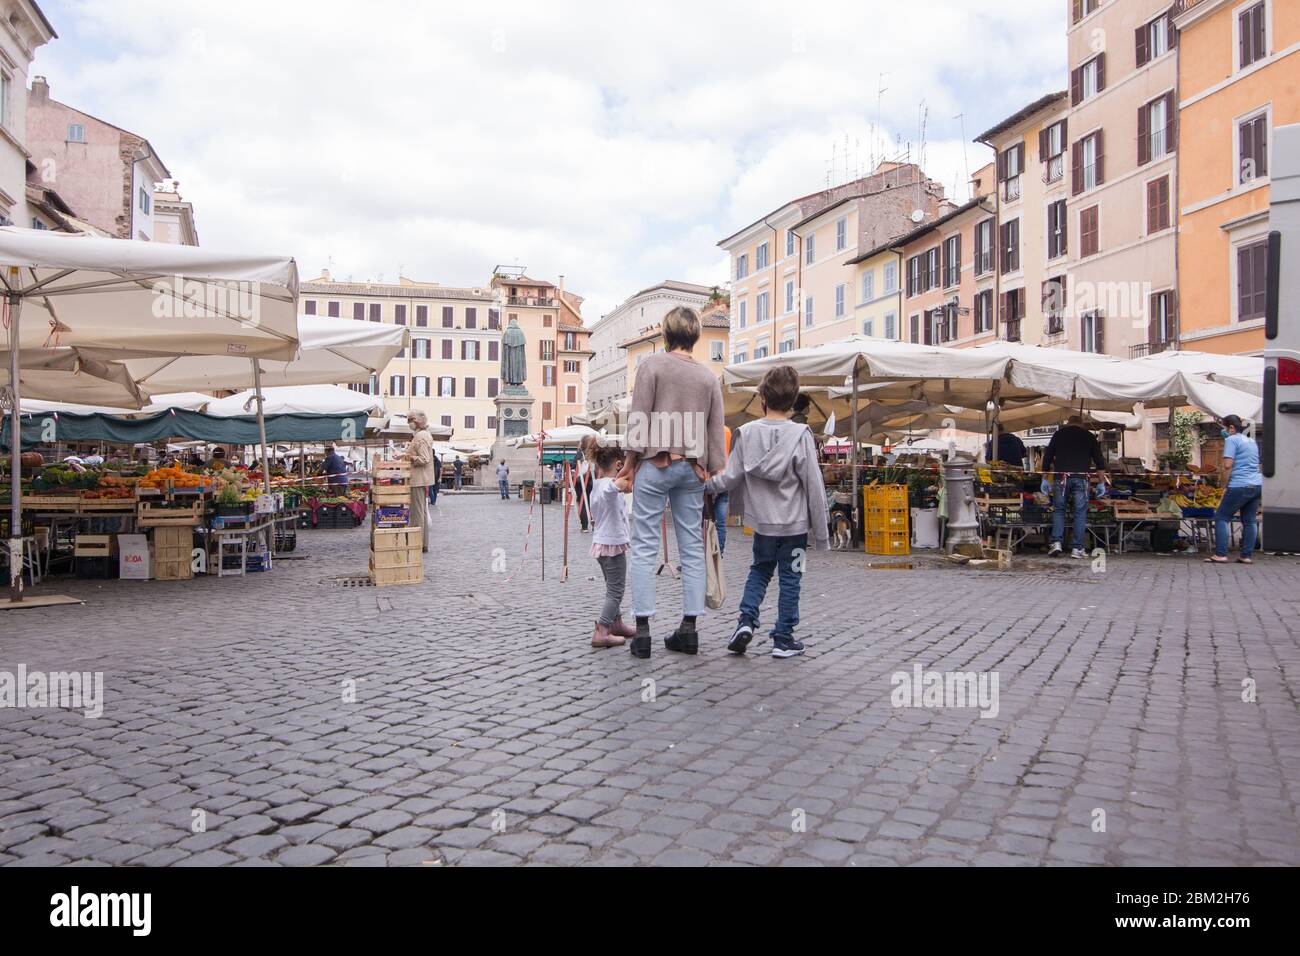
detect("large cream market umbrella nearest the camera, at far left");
top-left (0, 226), bottom-right (298, 605)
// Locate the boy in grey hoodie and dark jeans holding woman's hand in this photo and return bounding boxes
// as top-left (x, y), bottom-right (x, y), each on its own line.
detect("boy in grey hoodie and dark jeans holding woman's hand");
top-left (705, 365), bottom-right (829, 657)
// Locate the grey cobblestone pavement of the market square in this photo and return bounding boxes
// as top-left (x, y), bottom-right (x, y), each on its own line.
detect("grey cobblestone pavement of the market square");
top-left (0, 496), bottom-right (1300, 865)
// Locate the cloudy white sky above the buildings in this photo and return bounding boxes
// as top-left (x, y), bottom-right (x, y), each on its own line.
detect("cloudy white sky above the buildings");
top-left (33, 0), bottom-right (1066, 323)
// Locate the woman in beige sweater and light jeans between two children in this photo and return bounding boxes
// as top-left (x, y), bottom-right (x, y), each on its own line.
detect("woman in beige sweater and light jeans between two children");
top-left (619, 307), bottom-right (725, 658)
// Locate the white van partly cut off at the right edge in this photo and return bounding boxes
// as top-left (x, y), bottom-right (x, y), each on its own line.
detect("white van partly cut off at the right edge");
top-left (1260, 124), bottom-right (1300, 551)
